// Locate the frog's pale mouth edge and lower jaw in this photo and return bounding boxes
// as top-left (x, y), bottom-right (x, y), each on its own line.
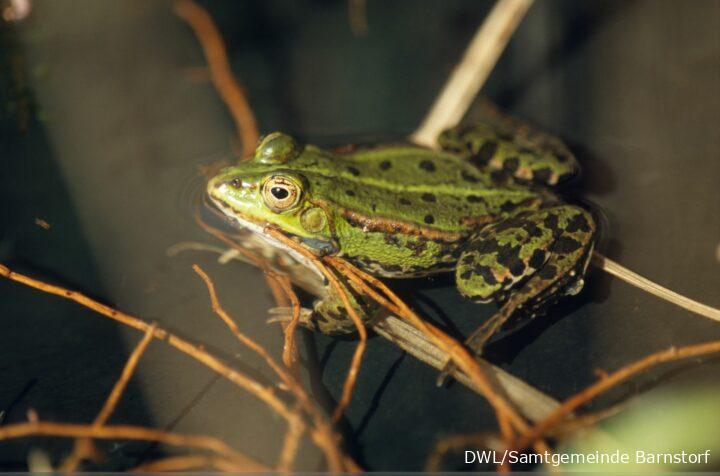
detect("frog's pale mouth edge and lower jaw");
top-left (209, 196), bottom-right (330, 279)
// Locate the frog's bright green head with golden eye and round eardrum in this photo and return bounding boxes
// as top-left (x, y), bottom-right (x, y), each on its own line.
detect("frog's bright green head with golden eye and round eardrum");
top-left (207, 132), bottom-right (335, 252)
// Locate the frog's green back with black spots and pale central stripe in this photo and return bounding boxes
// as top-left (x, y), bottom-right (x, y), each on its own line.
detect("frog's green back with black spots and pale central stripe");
top-left (295, 145), bottom-right (537, 233)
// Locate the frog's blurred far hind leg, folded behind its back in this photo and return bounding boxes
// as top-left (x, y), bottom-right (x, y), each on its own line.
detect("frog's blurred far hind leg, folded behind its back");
top-left (437, 123), bottom-right (578, 185)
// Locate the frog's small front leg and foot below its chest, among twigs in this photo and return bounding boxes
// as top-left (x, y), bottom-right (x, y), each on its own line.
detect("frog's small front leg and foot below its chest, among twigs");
top-left (270, 273), bottom-right (384, 335)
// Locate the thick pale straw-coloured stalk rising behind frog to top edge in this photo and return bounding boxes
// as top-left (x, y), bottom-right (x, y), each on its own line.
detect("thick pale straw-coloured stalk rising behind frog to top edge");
top-left (410, 0), bottom-right (532, 147)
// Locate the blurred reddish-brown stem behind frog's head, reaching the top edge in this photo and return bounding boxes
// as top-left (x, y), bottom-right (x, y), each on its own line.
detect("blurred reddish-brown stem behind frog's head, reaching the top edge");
top-left (174, 0), bottom-right (258, 157)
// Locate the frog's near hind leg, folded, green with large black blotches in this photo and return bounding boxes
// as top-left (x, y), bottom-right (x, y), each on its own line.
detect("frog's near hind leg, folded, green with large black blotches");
top-left (439, 205), bottom-right (595, 383)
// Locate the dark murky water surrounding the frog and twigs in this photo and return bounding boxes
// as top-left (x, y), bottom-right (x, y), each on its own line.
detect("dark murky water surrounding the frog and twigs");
top-left (0, 0), bottom-right (720, 470)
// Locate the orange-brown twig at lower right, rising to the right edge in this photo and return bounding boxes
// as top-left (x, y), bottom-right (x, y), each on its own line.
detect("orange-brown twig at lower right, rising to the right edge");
top-left (513, 341), bottom-right (720, 449)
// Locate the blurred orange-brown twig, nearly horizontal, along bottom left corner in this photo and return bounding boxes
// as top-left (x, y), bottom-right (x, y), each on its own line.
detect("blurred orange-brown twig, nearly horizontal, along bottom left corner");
top-left (0, 422), bottom-right (268, 471)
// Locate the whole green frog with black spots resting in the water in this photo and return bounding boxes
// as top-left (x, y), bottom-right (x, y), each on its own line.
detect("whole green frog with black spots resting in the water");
top-left (207, 123), bottom-right (597, 380)
